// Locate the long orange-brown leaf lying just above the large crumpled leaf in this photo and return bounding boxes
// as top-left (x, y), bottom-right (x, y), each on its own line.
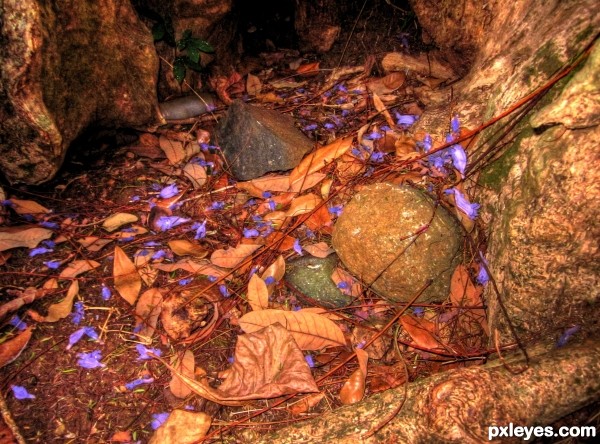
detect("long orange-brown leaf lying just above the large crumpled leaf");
top-left (239, 309), bottom-right (346, 350)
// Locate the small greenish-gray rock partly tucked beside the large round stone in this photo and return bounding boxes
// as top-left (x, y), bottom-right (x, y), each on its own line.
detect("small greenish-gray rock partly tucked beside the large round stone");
top-left (285, 254), bottom-right (352, 308)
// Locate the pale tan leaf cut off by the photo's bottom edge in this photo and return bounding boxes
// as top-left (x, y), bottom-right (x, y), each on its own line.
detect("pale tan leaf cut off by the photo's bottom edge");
top-left (148, 410), bottom-right (212, 444)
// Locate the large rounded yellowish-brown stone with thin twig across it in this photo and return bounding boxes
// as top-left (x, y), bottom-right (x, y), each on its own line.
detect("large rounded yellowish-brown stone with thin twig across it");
top-left (333, 183), bottom-right (463, 302)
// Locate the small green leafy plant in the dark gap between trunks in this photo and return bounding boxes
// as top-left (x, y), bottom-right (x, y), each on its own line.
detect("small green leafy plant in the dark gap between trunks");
top-left (152, 19), bottom-right (215, 83)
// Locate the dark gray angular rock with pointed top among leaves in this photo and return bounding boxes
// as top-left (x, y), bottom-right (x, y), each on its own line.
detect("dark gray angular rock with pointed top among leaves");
top-left (217, 100), bottom-right (313, 180)
